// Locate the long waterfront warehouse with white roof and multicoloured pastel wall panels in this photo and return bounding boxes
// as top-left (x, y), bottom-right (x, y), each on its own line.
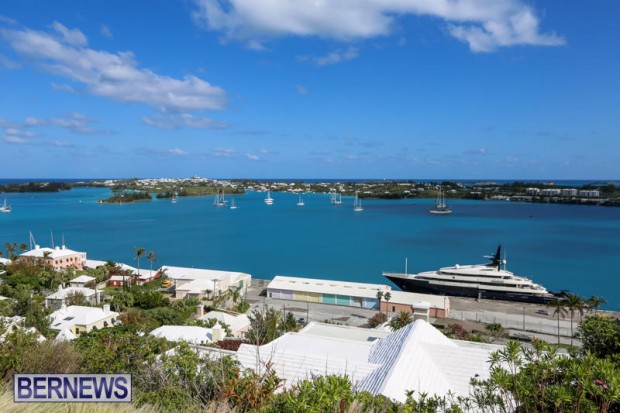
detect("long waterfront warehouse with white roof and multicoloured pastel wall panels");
top-left (267, 275), bottom-right (391, 309)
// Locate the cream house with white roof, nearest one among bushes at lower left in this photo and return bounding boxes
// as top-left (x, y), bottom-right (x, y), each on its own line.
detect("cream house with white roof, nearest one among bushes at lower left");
top-left (49, 304), bottom-right (119, 340)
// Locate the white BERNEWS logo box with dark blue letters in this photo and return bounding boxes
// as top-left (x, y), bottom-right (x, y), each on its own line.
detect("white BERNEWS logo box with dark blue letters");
top-left (13, 374), bottom-right (132, 403)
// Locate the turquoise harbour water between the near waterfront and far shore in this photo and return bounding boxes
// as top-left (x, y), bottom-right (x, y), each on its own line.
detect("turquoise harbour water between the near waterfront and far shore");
top-left (0, 188), bottom-right (620, 309)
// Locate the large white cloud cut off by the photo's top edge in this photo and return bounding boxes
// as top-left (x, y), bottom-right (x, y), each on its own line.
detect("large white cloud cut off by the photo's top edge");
top-left (192, 0), bottom-right (564, 52)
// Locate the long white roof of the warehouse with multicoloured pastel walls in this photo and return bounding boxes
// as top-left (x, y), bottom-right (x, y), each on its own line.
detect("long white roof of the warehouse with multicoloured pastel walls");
top-left (267, 275), bottom-right (390, 299)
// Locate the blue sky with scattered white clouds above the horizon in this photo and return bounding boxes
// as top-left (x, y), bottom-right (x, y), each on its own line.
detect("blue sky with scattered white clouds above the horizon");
top-left (0, 0), bottom-right (620, 179)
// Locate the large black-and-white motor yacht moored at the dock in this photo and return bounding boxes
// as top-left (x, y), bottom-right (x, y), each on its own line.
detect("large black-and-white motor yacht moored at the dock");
top-left (383, 245), bottom-right (556, 304)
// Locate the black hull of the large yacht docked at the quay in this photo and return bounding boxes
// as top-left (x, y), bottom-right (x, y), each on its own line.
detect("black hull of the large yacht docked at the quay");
top-left (385, 275), bottom-right (555, 304)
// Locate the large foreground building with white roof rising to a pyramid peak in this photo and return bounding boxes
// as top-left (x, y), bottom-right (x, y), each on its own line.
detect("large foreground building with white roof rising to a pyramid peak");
top-left (237, 320), bottom-right (502, 402)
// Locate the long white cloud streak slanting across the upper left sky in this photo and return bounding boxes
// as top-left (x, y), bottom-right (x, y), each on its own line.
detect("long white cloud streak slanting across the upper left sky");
top-left (0, 23), bottom-right (226, 112)
